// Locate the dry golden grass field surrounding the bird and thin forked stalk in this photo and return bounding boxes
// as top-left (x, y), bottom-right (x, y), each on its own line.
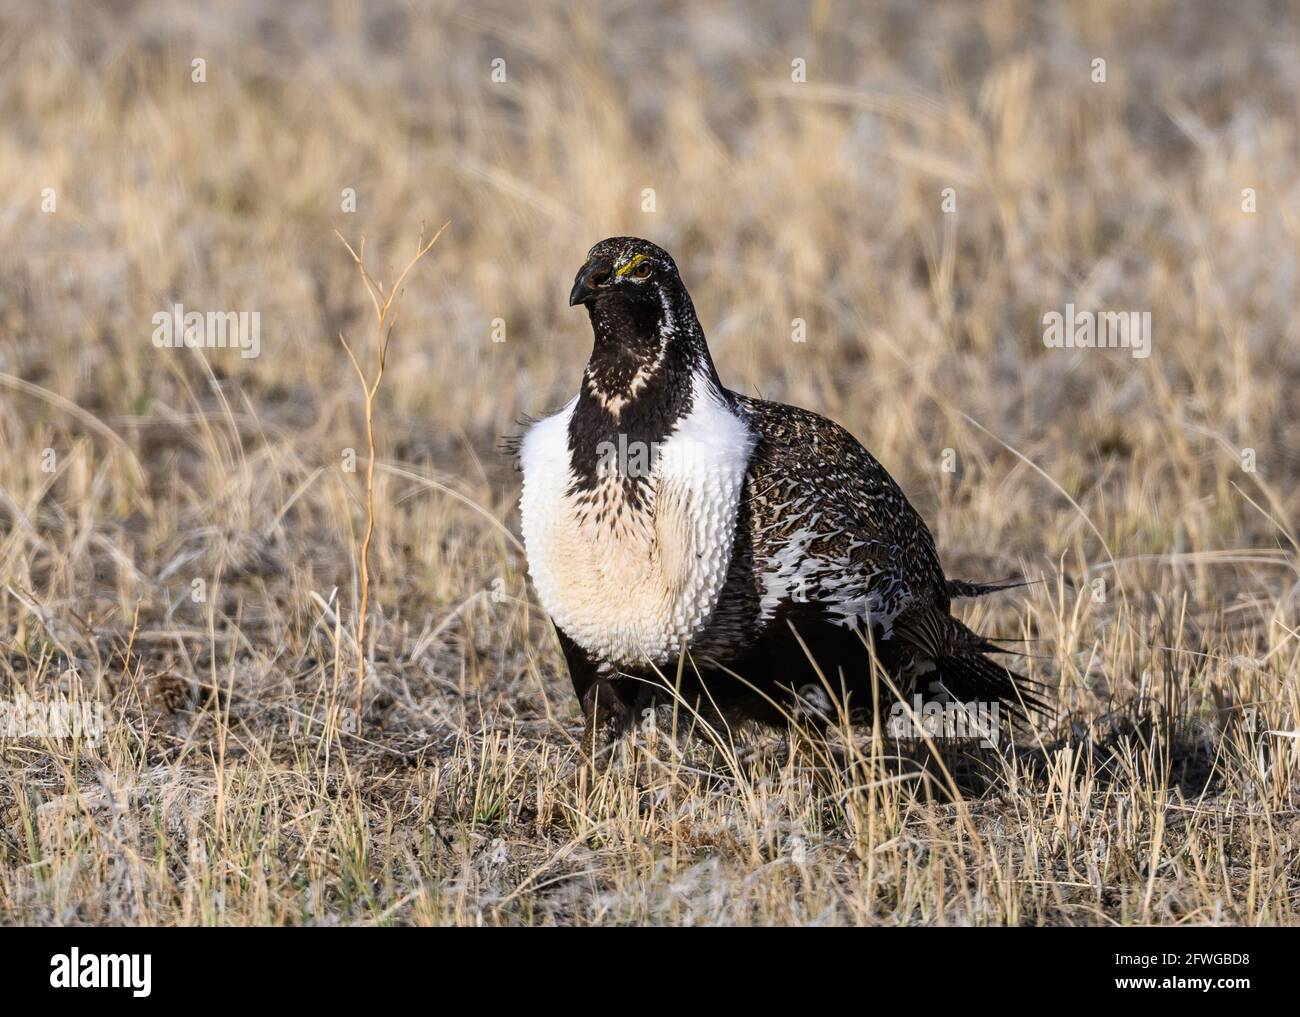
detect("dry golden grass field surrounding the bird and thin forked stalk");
top-left (0, 0), bottom-right (1300, 925)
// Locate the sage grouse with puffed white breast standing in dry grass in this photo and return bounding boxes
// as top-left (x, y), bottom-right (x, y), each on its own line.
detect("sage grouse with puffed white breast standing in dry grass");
top-left (519, 237), bottom-right (1040, 744)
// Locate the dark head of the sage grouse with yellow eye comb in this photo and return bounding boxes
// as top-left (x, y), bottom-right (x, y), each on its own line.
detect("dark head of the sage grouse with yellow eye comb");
top-left (569, 237), bottom-right (716, 417)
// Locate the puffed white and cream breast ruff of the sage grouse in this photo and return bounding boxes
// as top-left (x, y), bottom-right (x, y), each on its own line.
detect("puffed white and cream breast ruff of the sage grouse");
top-left (520, 377), bottom-right (755, 667)
